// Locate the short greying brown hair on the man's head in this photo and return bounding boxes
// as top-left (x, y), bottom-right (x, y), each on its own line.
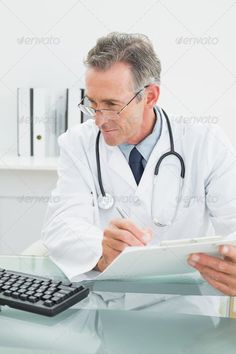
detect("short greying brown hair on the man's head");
top-left (84, 32), bottom-right (161, 98)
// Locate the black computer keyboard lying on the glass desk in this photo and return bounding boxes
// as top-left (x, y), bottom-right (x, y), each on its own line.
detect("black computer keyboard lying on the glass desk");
top-left (0, 268), bottom-right (89, 316)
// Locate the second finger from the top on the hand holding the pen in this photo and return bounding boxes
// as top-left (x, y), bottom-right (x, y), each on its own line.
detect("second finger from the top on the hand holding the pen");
top-left (104, 227), bottom-right (145, 246)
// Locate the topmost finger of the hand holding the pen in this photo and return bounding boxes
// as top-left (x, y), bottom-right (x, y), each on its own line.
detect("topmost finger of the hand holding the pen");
top-left (112, 219), bottom-right (151, 244)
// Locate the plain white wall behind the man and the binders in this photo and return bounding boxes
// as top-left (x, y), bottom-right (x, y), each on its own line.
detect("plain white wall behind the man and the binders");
top-left (0, 0), bottom-right (236, 252)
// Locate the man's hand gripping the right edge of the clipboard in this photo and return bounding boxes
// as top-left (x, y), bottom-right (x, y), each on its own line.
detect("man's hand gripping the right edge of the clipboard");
top-left (188, 245), bottom-right (236, 296)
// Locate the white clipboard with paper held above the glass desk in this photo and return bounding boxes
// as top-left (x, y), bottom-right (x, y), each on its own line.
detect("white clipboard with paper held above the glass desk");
top-left (96, 236), bottom-right (236, 280)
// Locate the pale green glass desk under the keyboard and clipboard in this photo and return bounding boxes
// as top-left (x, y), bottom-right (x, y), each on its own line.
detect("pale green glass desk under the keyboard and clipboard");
top-left (0, 256), bottom-right (236, 354)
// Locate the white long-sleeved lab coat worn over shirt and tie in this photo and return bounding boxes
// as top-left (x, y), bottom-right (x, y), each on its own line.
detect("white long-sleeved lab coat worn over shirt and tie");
top-left (42, 109), bottom-right (236, 278)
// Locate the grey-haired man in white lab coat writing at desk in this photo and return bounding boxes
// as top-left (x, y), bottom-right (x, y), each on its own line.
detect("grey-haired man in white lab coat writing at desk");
top-left (43, 33), bottom-right (236, 295)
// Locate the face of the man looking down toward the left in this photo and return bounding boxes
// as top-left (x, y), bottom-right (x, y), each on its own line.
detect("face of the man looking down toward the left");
top-left (86, 63), bottom-right (145, 146)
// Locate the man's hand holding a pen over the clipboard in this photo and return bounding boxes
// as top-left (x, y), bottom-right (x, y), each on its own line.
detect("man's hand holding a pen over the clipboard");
top-left (96, 219), bottom-right (152, 272)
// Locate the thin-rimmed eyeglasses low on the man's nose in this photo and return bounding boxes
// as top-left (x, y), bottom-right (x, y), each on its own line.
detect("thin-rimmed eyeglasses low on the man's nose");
top-left (78, 85), bottom-right (149, 119)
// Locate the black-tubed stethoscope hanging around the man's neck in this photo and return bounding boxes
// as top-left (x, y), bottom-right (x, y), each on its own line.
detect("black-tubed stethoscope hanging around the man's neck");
top-left (95, 109), bottom-right (185, 226)
